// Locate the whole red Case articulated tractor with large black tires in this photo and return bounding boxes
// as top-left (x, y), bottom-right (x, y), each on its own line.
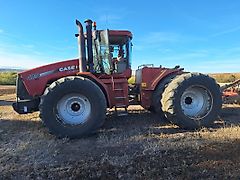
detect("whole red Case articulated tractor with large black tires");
top-left (13, 20), bottom-right (222, 138)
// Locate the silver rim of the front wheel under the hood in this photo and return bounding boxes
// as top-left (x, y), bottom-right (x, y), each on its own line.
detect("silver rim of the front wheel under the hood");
top-left (57, 94), bottom-right (91, 125)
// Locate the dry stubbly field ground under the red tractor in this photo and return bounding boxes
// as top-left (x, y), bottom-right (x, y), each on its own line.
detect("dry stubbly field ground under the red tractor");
top-left (0, 87), bottom-right (240, 179)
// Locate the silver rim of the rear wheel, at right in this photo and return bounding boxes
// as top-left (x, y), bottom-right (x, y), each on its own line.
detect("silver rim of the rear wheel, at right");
top-left (181, 86), bottom-right (213, 119)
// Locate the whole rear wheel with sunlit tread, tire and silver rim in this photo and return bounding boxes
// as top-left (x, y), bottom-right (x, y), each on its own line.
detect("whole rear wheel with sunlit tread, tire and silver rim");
top-left (162, 73), bottom-right (222, 129)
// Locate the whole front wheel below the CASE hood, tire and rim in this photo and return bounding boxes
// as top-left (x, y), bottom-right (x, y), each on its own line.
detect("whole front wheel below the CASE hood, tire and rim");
top-left (39, 77), bottom-right (106, 138)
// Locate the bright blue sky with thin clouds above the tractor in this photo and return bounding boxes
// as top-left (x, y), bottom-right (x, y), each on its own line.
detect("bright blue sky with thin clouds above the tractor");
top-left (0, 0), bottom-right (240, 73)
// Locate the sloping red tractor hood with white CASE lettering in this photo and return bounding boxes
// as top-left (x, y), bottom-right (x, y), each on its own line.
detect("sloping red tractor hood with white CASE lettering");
top-left (18, 59), bottom-right (79, 97)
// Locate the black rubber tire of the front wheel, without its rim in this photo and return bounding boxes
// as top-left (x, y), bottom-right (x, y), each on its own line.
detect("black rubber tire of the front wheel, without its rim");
top-left (42, 78), bottom-right (106, 137)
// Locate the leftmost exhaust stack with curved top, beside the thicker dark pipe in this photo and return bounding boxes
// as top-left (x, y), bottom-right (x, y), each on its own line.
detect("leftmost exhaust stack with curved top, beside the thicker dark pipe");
top-left (75, 20), bottom-right (87, 72)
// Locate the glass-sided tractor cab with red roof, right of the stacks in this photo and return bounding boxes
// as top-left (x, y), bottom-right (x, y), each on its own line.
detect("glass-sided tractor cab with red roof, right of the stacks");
top-left (93, 30), bottom-right (132, 74)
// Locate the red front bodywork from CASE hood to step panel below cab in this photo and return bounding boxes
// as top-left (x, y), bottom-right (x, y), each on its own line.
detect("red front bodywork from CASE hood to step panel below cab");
top-left (19, 59), bottom-right (132, 108)
